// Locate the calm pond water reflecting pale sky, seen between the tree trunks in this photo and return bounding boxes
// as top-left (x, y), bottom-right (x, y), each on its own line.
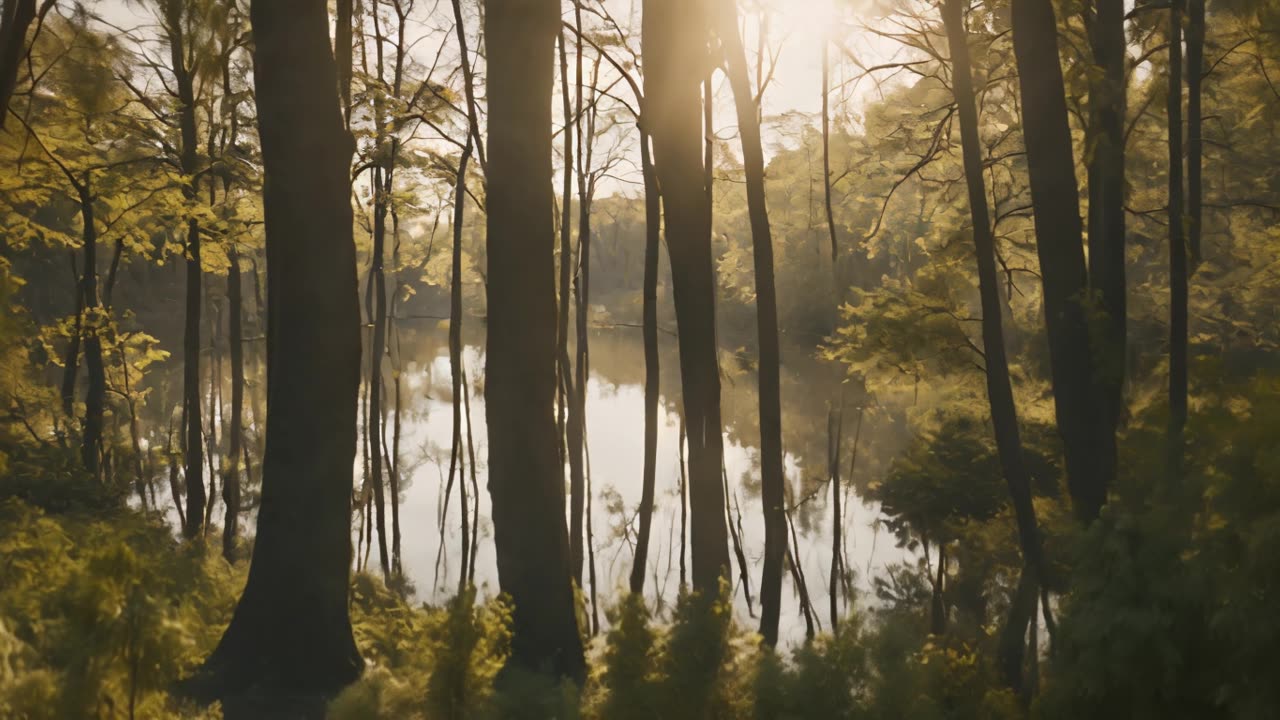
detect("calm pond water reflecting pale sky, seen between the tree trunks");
top-left (148, 320), bottom-right (906, 641)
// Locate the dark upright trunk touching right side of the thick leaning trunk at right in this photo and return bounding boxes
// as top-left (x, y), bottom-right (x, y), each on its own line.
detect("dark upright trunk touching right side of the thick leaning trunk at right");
top-left (1088, 0), bottom-right (1128, 461)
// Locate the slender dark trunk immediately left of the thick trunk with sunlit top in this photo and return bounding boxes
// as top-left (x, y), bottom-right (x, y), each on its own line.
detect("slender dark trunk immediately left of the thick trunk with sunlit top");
top-left (631, 127), bottom-right (662, 594)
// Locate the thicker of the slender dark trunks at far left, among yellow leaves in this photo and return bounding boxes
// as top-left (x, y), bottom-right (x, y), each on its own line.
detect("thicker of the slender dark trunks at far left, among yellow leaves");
top-left (78, 178), bottom-right (106, 479)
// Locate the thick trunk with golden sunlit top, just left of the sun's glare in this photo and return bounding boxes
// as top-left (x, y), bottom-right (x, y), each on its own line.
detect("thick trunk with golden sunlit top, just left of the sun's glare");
top-left (643, 0), bottom-right (730, 594)
